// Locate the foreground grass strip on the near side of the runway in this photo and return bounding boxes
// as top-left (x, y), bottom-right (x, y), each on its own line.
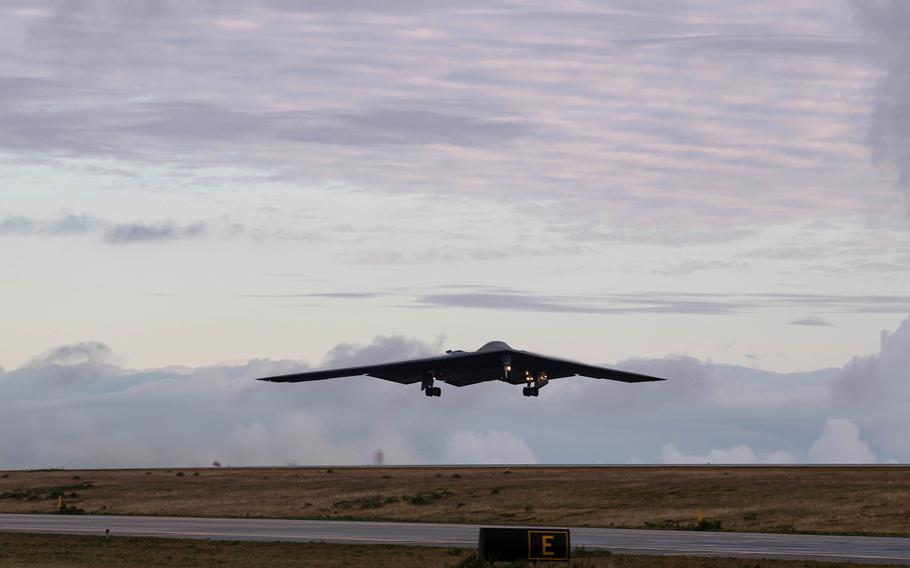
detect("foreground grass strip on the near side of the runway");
top-left (0, 532), bottom-right (904, 568)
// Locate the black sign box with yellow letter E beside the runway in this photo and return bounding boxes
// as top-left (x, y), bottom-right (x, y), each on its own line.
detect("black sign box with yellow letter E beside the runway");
top-left (479, 527), bottom-right (571, 562)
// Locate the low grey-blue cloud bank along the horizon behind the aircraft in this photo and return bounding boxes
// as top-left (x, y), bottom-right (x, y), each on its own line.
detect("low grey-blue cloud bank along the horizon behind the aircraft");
top-left (0, 318), bottom-right (910, 468)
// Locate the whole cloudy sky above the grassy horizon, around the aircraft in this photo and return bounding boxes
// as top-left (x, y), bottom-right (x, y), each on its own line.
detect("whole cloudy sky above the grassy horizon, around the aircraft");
top-left (0, 0), bottom-right (910, 468)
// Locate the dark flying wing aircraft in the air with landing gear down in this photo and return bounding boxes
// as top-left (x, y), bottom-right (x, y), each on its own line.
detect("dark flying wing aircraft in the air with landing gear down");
top-left (257, 341), bottom-right (664, 396)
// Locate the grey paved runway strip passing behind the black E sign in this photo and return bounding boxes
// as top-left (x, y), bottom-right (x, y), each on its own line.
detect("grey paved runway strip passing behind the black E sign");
top-left (0, 514), bottom-right (910, 564)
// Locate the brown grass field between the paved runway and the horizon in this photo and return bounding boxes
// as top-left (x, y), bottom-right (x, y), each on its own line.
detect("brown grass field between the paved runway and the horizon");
top-left (0, 467), bottom-right (910, 536)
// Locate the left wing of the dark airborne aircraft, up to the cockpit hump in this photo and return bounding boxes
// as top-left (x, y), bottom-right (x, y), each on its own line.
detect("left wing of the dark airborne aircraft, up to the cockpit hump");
top-left (258, 352), bottom-right (500, 385)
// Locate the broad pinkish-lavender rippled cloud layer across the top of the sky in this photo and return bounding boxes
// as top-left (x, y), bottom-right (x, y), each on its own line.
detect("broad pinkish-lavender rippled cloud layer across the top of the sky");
top-left (0, 0), bottom-right (881, 232)
